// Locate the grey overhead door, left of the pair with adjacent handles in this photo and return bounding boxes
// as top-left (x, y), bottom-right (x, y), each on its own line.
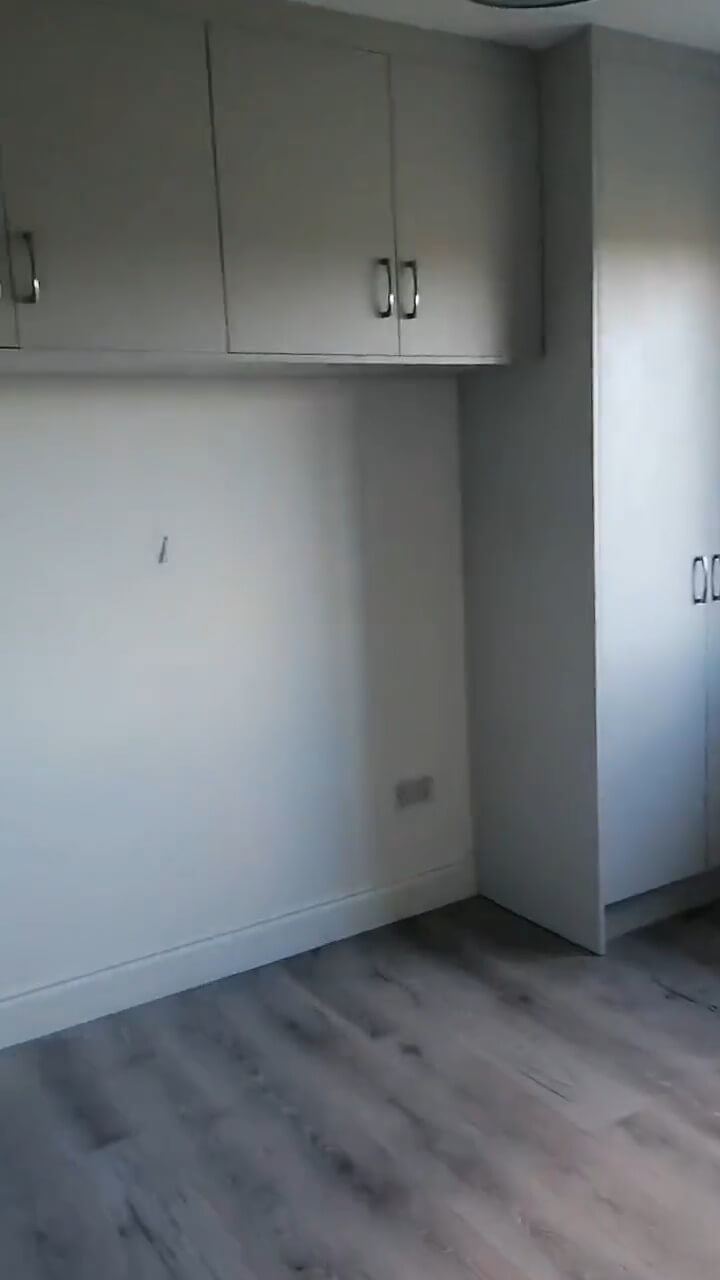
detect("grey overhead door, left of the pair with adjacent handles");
top-left (211, 26), bottom-right (398, 356)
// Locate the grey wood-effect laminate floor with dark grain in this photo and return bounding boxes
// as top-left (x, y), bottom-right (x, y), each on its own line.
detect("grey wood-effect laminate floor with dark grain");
top-left (0, 902), bottom-right (720, 1280)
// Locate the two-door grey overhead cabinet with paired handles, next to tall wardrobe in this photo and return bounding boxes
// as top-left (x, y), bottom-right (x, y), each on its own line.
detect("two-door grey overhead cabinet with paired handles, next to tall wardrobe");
top-left (211, 24), bottom-right (541, 362)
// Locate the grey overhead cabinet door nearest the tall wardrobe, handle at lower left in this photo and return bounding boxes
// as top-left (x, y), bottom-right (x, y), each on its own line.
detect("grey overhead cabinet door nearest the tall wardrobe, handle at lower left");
top-left (392, 55), bottom-right (541, 361)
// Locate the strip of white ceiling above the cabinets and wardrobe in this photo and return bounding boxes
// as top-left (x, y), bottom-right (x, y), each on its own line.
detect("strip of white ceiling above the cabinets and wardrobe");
top-left (288, 0), bottom-right (720, 51)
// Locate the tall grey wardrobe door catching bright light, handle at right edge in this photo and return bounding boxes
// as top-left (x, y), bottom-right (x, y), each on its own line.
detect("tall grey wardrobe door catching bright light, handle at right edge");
top-left (596, 61), bottom-right (720, 902)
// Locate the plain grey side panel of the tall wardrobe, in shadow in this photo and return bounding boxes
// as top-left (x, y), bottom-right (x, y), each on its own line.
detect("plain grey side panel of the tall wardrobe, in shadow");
top-left (461, 37), bottom-right (603, 950)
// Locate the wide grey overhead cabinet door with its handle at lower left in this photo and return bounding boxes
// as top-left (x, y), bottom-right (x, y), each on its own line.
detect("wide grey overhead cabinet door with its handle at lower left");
top-left (0, 0), bottom-right (225, 352)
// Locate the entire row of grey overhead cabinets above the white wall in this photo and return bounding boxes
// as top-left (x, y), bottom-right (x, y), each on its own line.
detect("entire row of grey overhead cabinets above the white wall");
top-left (0, 0), bottom-right (541, 362)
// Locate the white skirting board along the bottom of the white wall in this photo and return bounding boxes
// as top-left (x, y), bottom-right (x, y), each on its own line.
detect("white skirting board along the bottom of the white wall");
top-left (0, 858), bottom-right (475, 1048)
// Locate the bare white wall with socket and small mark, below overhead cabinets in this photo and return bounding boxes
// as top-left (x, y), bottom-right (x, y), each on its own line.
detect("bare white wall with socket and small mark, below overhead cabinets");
top-left (0, 378), bottom-right (470, 1041)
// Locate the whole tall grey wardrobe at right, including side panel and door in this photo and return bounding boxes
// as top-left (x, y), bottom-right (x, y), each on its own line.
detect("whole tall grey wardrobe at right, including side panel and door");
top-left (456, 31), bottom-right (720, 950)
